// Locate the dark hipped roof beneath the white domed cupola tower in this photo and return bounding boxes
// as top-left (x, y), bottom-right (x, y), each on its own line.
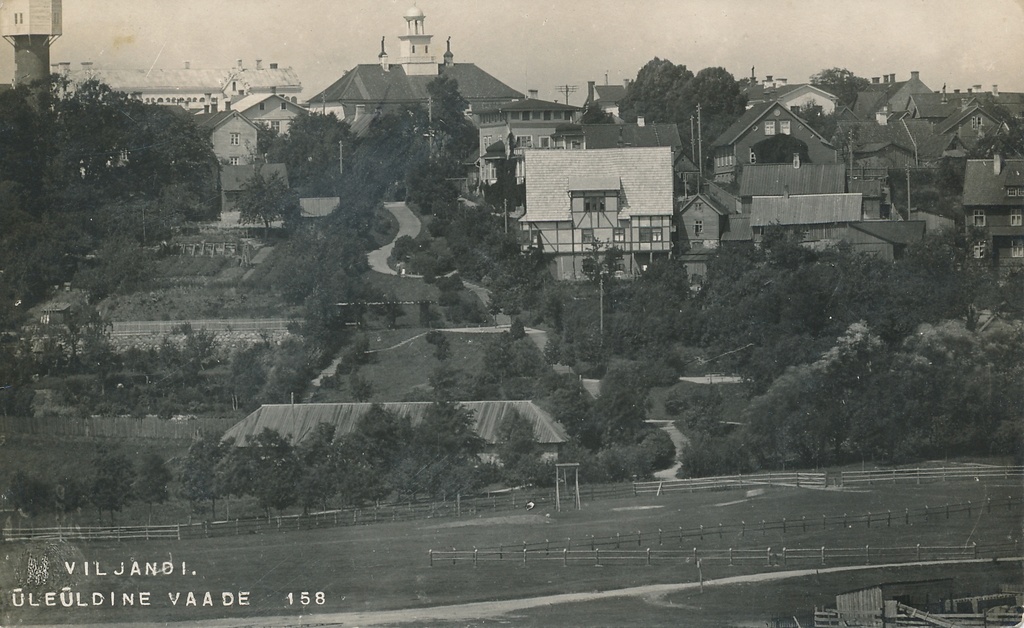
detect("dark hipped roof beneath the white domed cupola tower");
top-left (309, 64), bottom-right (524, 107)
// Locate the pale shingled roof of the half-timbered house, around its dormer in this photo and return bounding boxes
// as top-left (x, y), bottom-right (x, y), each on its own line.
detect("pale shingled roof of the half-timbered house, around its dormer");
top-left (522, 146), bottom-right (673, 221)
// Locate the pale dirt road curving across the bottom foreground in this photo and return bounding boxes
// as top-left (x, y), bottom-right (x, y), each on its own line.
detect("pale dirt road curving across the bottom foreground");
top-left (86, 558), bottom-right (1021, 628)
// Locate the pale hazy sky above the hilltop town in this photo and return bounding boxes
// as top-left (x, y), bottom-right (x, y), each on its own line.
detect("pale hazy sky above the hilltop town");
top-left (0, 0), bottom-right (1024, 104)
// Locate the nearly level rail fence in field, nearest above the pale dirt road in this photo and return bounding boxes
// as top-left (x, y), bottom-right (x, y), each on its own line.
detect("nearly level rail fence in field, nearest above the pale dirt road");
top-left (427, 543), bottom-right (1020, 568)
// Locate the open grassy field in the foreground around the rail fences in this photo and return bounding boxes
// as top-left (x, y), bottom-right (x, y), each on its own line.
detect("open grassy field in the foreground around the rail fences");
top-left (0, 482), bottom-right (1022, 626)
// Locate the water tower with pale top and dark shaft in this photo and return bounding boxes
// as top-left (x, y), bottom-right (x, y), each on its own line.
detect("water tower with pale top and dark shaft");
top-left (0, 0), bottom-right (61, 85)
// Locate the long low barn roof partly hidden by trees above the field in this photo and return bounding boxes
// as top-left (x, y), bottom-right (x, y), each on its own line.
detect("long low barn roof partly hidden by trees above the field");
top-left (224, 401), bottom-right (568, 446)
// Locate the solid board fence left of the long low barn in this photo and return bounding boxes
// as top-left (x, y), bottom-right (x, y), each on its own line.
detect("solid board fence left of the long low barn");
top-left (0, 417), bottom-right (238, 441)
